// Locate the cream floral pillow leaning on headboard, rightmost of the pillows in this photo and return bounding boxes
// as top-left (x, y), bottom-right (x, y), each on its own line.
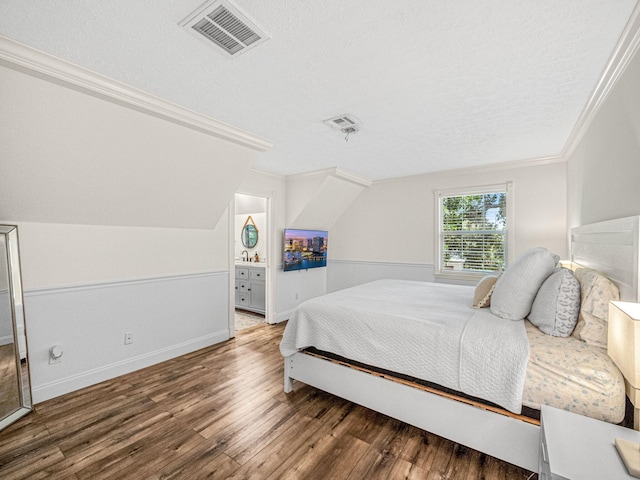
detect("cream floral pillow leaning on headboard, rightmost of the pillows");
top-left (573, 268), bottom-right (620, 348)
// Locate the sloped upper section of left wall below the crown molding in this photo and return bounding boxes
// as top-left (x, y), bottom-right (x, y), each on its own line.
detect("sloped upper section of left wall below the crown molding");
top-left (0, 66), bottom-right (257, 229)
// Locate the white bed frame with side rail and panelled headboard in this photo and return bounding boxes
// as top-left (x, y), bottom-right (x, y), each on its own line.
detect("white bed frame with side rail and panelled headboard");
top-left (284, 216), bottom-right (640, 471)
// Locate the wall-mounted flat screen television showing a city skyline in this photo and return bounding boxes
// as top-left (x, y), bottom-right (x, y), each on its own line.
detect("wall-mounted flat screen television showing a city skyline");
top-left (283, 228), bottom-right (329, 272)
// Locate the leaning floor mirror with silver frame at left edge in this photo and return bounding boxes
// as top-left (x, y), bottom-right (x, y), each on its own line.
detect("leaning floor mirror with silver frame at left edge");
top-left (0, 225), bottom-right (32, 429)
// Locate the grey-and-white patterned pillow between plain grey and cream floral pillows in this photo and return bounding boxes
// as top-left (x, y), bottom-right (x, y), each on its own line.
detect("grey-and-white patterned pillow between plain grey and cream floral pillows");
top-left (529, 268), bottom-right (580, 337)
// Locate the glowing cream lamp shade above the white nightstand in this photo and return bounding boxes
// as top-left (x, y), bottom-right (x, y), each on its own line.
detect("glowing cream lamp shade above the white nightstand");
top-left (607, 302), bottom-right (640, 389)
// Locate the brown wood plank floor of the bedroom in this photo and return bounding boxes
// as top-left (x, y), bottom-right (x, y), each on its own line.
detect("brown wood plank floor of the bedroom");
top-left (0, 324), bottom-right (536, 480)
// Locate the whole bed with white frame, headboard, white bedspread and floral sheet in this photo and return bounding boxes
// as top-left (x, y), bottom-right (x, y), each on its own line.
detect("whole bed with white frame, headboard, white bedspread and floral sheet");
top-left (281, 217), bottom-right (639, 471)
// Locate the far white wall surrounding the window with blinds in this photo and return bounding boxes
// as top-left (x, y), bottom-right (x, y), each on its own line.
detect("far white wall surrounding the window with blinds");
top-left (328, 162), bottom-right (568, 291)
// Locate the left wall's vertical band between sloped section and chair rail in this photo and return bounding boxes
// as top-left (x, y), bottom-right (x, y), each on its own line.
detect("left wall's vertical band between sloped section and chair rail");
top-left (9, 221), bottom-right (227, 290)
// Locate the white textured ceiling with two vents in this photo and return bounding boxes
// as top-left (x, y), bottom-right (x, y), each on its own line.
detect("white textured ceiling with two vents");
top-left (0, 0), bottom-right (636, 180)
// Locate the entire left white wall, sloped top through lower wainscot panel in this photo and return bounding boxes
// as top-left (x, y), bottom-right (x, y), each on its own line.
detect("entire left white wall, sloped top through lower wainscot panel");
top-left (0, 51), bottom-right (258, 402)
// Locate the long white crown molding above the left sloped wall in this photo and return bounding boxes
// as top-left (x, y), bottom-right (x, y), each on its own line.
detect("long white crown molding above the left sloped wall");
top-left (0, 35), bottom-right (273, 152)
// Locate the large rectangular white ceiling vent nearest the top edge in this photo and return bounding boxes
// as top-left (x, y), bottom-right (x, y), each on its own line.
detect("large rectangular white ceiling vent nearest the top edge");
top-left (180, 0), bottom-right (271, 58)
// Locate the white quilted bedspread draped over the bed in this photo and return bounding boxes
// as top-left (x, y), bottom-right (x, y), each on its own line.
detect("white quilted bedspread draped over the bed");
top-left (280, 280), bottom-right (529, 413)
